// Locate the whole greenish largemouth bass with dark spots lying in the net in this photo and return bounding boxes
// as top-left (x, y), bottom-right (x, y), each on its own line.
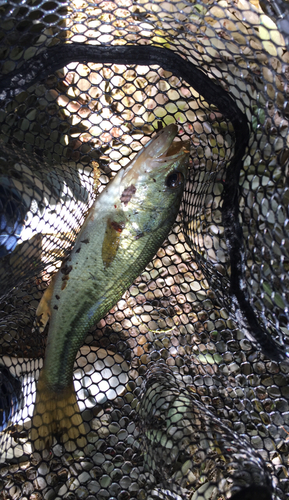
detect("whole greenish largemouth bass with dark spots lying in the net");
top-left (30, 124), bottom-right (190, 452)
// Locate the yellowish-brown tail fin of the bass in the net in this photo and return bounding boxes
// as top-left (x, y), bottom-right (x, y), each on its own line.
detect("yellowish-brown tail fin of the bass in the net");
top-left (30, 370), bottom-right (87, 452)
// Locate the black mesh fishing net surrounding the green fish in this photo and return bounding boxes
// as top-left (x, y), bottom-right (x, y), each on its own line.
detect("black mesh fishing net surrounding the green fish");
top-left (0, 0), bottom-right (289, 500)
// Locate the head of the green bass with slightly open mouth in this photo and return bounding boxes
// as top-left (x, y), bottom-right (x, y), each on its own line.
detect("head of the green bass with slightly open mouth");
top-left (120, 124), bottom-right (190, 234)
